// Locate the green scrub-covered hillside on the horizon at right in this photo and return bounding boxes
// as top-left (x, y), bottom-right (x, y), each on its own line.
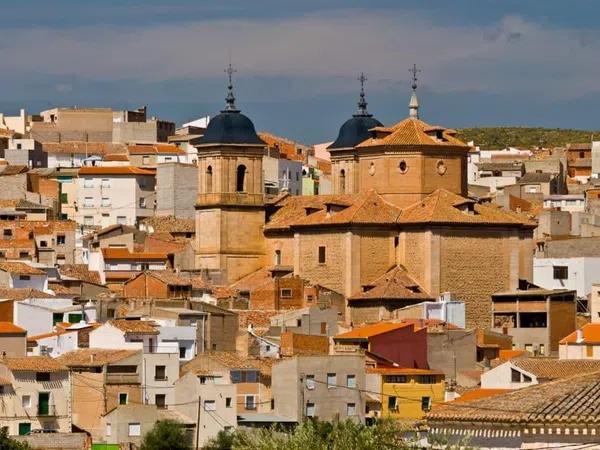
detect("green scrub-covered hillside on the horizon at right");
top-left (457, 127), bottom-right (600, 150)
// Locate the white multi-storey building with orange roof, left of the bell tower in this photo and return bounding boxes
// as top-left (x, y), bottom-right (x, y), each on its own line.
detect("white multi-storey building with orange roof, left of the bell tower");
top-left (76, 166), bottom-right (156, 228)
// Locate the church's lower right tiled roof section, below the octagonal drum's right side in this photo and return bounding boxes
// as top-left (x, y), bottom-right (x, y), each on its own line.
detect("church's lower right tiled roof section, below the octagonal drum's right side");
top-left (398, 189), bottom-right (537, 227)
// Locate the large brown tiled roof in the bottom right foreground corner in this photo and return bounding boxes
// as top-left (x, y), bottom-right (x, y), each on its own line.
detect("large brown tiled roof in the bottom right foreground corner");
top-left (426, 372), bottom-right (600, 426)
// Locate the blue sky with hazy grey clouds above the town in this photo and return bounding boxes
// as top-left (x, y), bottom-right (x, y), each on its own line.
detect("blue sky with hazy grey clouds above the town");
top-left (0, 0), bottom-right (600, 143)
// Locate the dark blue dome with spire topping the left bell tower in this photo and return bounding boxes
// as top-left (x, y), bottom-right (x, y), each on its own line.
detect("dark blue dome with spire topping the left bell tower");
top-left (199, 64), bottom-right (265, 145)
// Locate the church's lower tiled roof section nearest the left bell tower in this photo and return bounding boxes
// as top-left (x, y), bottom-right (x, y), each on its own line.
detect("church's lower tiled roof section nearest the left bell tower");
top-left (265, 190), bottom-right (400, 230)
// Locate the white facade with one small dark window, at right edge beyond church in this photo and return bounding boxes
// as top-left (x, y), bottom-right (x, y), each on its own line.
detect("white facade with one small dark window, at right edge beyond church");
top-left (533, 257), bottom-right (600, 297)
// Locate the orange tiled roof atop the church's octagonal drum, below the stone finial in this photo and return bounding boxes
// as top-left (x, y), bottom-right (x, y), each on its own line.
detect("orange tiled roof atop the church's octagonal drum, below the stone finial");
top-left (357, 117), bottom-right (469, 152)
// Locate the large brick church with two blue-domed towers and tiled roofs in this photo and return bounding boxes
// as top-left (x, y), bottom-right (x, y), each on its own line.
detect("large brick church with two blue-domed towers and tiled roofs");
top-left (196, 70), bottom-right (536, 327)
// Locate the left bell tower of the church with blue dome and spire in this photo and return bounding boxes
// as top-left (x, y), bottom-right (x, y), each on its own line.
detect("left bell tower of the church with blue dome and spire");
top-left (196, 64), bottom-right (265, 283)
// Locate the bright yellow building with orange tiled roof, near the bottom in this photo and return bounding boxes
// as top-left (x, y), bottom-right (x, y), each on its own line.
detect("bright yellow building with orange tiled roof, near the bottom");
top-left (367, 367), bottom-right (445, 420)
